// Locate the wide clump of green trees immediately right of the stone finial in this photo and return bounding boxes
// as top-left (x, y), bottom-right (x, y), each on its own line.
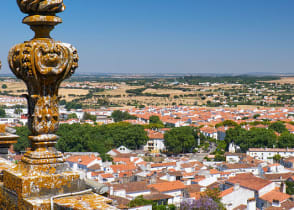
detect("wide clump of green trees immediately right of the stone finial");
top-left (57, 122), bottom-right (148, 155)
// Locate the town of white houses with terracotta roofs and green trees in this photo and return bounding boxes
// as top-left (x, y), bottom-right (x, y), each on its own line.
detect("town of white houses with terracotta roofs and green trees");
top-left (0, 76), bottom-right (294, 210)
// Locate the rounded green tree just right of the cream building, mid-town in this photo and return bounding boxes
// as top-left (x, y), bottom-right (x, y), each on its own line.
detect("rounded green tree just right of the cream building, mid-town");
top-left (164, 126), bottom-right (197, 154)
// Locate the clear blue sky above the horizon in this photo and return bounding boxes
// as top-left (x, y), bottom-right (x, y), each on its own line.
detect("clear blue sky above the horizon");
top-left (0, 0), bottom-right (294, 73)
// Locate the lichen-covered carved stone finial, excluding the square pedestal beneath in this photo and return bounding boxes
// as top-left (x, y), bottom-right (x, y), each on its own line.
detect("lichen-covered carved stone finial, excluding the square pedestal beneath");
top-left (8, 0), bottom-right (79, 164)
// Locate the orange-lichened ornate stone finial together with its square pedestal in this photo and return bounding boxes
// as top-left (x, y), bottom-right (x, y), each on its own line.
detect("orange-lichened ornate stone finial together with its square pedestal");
top-left (0, 0), bottom-right (85, 209)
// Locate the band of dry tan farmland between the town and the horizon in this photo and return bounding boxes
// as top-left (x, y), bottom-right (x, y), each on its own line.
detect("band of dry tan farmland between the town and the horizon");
top-left (0, 77), bottom-right (294, 108)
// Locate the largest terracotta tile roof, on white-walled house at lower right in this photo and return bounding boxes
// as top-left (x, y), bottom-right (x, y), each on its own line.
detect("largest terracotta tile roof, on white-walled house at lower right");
top-left (226, 173), bottom-right (272, 191)
